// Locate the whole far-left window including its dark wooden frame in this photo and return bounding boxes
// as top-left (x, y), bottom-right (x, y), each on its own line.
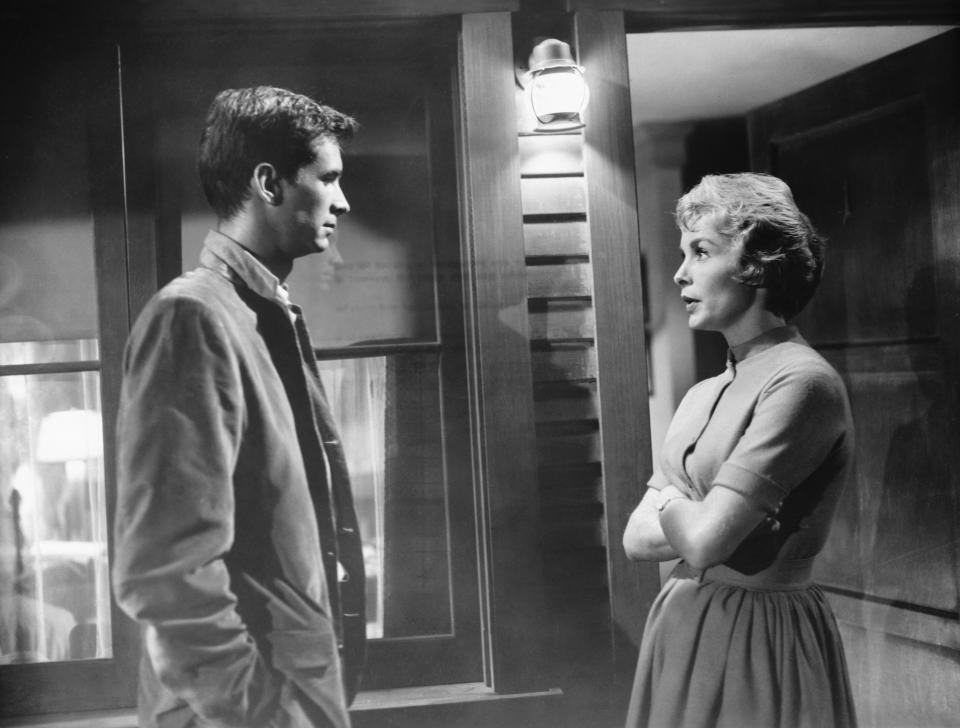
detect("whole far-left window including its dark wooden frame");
top-left (0, 34), bottom-right (132, 716)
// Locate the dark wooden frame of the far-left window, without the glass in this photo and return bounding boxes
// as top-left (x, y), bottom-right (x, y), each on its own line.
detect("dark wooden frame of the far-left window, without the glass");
top-left (0, 34), bottom-right (139, 718)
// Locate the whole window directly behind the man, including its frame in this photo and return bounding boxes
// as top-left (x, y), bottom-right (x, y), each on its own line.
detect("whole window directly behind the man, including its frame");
top-left (139, 22), bottom-right (484, 689)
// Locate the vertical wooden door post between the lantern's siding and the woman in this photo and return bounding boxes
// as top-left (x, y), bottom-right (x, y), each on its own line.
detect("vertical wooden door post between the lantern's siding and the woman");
top-left (575, 11), bottom-right (660, 664)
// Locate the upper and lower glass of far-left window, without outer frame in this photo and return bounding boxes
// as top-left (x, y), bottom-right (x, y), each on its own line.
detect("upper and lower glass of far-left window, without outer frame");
top-left (0, 55), bottom-right (112, 664)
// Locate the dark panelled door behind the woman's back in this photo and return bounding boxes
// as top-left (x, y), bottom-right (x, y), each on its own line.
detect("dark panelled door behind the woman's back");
top-left (749, 31), bottom-right (960, 727)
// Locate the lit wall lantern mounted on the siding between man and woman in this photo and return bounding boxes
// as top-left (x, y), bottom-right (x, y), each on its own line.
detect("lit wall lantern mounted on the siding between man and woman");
top-left (524, 38), bottom-right (589, 132)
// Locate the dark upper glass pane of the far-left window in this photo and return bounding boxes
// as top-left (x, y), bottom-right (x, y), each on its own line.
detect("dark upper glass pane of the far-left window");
top-left (0, 60), bottom-right (98, 363)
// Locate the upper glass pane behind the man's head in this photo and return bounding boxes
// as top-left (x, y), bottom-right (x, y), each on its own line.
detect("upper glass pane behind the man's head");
top-left (174, 75), bottom-right (437, 348)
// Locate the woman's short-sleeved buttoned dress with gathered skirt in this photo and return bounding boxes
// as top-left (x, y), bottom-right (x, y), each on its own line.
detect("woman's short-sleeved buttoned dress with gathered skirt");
top-left (627, 326), bottom-right (856, 728)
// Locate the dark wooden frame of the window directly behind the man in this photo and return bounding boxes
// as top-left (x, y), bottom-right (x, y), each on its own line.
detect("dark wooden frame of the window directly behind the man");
top-left (124, 18), bottom-right (489, 690)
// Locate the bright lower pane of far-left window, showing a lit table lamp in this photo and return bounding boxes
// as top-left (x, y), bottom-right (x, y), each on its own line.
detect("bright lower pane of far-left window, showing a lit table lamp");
top-left (0, 372), bottom-right (112, 663)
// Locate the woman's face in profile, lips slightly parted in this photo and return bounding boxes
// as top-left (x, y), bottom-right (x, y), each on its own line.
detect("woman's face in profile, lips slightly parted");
top-left (673, 217), bottom-right (761, 344)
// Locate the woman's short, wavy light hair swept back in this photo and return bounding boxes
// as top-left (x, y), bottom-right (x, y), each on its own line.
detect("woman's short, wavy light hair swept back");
top-left (676, 172), bottom-right (826, 319)
